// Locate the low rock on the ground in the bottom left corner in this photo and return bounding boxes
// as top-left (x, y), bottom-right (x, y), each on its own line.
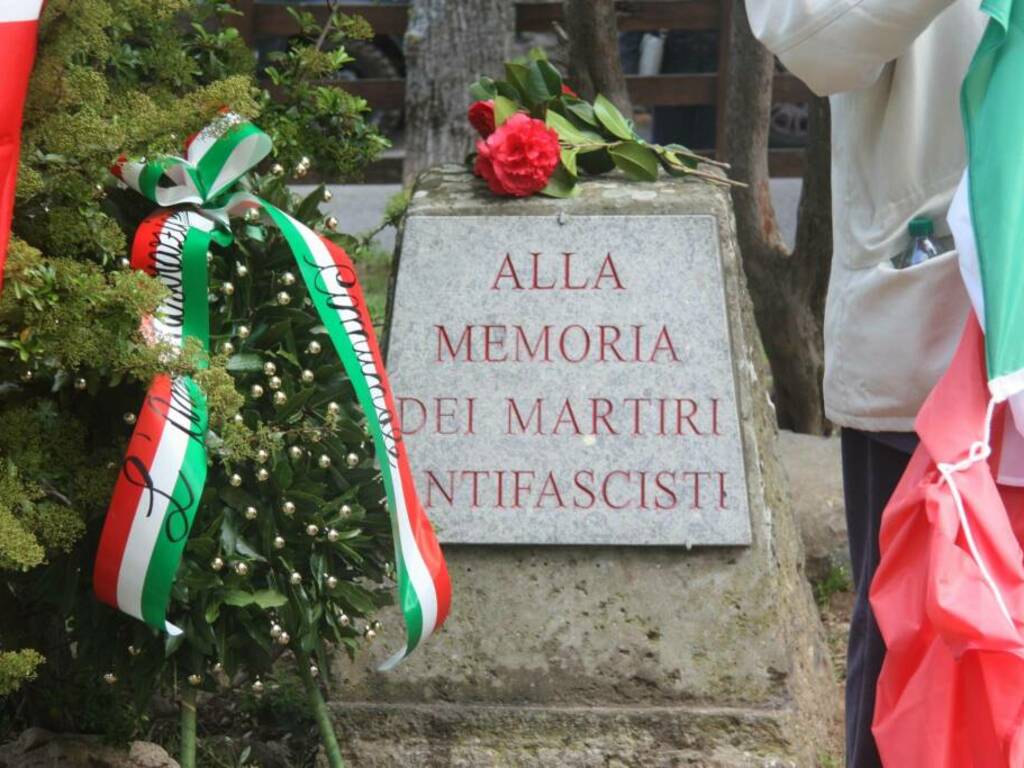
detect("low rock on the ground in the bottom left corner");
top-left (0, 728), bottom-right (179, 768)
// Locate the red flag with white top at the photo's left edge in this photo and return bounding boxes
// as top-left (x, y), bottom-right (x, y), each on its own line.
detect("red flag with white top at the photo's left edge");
top-left (0, 0), bottom-right (43, 290)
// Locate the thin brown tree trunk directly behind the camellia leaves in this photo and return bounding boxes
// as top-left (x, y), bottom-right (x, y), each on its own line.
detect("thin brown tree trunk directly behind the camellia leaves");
top-left (565, 0), bottom-right (633, 115)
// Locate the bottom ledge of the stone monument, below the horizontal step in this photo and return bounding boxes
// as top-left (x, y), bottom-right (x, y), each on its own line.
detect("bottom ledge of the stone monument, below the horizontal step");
top-left (336, 703), bottom-right (809, 768)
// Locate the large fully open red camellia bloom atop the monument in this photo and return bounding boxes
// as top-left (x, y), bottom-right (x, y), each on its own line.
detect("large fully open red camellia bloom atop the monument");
top-left (473, 113), bottom-right (561, 198)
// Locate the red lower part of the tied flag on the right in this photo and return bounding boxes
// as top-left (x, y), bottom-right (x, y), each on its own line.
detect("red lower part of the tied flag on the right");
top-left (871, 314), bottom-right (1024, 768)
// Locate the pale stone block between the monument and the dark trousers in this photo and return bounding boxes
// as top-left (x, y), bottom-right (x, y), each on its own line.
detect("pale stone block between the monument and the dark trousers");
top-left (778, 432), bottom-right (850, 580)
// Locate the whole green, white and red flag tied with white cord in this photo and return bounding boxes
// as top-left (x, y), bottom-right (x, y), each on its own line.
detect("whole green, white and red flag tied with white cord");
top-left (870, 0), bottom-right (1024, 768)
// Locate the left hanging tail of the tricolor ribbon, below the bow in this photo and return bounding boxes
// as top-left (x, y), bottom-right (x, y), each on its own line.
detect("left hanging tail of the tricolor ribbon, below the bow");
top-left (93, 209), bottom-right (223, 635)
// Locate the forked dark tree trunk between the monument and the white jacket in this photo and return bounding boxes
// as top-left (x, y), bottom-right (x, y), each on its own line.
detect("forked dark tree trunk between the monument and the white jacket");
top-left (723, 0), bottom-right (833, 434)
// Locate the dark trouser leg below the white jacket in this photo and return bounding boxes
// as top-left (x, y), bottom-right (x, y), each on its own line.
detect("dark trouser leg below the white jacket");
top-left (843, 429), bottom-right (913, 768)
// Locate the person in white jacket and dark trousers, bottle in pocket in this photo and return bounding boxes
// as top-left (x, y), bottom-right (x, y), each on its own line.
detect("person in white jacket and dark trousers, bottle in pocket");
top-left (734, 0), bottom-right (986, 768)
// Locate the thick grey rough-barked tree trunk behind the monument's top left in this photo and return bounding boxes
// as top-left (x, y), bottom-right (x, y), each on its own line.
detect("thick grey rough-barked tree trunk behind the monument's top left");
top-left (404, 0), bottom-right (515, 182)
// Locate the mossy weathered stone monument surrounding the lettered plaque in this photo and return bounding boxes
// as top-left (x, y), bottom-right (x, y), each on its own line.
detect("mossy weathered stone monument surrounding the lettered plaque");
top-left (334, 169), bottom-right (837, 768)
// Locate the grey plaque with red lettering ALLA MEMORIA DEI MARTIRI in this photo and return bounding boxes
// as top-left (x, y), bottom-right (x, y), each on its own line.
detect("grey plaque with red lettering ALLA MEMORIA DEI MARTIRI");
top-left (388, 214), bottom-right (751, 547)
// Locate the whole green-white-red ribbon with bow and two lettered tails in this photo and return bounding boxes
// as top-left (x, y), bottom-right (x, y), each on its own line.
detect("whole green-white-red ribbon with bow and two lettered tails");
top-left (95, 115), bottom-right (452, 669)
